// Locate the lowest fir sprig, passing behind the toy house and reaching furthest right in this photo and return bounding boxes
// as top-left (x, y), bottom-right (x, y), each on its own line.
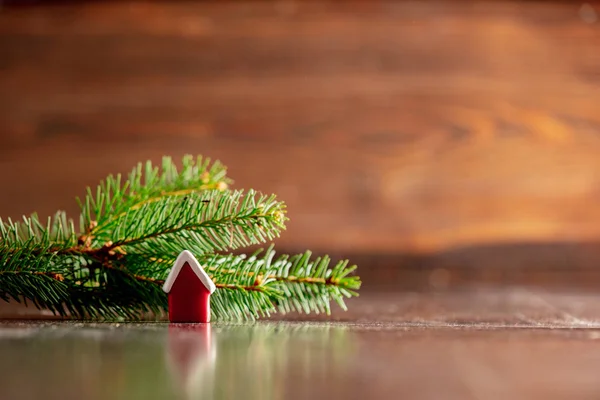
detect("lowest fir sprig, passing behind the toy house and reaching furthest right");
top-left (106, 244), bottom-right (361, 320)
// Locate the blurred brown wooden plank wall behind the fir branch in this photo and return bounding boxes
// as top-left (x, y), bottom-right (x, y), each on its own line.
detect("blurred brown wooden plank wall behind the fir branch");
top-left (0, 1), bottom-right (600, 253)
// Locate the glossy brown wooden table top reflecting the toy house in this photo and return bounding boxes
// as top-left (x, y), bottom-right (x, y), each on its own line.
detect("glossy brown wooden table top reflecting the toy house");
top-left (0, 290), bottom-right (600, 400)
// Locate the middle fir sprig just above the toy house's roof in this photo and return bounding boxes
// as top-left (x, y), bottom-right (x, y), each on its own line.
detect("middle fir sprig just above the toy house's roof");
top-left (102, 190), bottom-right (286, 255)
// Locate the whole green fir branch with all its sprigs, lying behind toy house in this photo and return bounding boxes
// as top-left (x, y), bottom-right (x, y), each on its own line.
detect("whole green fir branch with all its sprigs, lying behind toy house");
top-left (0, 156), bottom-right (360, 320)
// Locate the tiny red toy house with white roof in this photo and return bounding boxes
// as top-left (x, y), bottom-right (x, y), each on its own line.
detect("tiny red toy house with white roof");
top-left (163, 250), bottom-right (216, 323)
